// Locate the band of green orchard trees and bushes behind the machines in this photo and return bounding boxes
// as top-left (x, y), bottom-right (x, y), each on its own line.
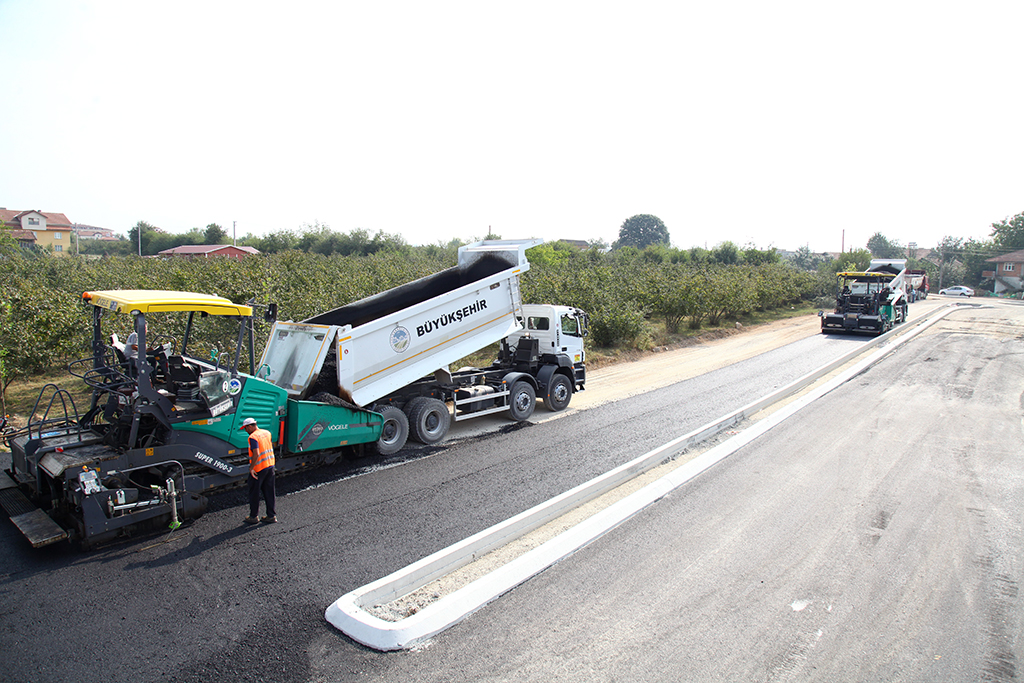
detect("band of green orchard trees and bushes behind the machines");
top-left (6, 205), bottom-right (1024, 411)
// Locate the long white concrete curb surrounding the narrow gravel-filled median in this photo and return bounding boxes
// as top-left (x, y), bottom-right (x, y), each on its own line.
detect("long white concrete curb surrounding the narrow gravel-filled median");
top-left (325, 306), bottom-right (954, 650)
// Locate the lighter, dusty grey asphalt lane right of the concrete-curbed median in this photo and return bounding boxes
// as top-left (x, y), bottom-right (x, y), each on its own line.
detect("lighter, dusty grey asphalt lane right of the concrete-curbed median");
top-left (346, 311), bottom-right (1024, 681)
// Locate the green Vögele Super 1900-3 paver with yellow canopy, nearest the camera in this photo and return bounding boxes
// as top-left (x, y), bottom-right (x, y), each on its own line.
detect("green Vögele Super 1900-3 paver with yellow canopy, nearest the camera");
top-left (0, 290), bottom-right (383, 547)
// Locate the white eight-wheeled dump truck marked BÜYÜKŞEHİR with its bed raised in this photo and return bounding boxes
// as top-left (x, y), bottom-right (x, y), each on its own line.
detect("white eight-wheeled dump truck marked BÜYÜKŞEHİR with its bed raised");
top-left (257, 240), bottom-right (588, 455)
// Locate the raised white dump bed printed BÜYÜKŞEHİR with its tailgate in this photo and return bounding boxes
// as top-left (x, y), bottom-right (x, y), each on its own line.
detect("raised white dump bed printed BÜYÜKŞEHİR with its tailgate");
top-left (261, 240), bottom-right (541, 405)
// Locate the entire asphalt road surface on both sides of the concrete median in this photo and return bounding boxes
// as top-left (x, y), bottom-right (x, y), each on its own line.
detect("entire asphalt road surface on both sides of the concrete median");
top-left (0, 307), bottom-right (1024, 681)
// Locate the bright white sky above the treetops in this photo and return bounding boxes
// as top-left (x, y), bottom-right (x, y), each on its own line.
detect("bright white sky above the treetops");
top-left (0, 0), bottom-right (1024, 251)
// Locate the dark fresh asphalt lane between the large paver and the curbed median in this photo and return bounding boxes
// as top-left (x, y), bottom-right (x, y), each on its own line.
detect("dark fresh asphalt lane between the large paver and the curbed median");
top-left (0, 321), bottom-right (929, 683)
